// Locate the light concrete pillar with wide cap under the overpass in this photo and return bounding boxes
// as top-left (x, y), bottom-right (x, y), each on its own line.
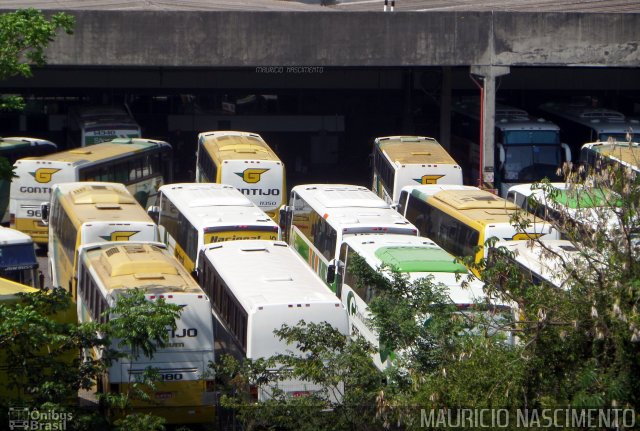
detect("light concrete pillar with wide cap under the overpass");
top-left (471, 66), bottom-right (510, 189)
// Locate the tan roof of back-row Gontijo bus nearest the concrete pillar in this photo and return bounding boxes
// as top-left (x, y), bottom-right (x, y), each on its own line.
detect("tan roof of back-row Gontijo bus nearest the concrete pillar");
top-left (375, 136), bottom-right (458, 165)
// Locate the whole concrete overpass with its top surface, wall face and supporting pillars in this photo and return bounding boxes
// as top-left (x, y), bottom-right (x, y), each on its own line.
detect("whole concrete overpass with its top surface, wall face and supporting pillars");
top-left (0, 0), bottom-right (640, 189)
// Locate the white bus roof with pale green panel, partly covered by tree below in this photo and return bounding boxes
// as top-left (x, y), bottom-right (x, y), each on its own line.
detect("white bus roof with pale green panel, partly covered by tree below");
top-left (344, 234), bottom-right (485, 304)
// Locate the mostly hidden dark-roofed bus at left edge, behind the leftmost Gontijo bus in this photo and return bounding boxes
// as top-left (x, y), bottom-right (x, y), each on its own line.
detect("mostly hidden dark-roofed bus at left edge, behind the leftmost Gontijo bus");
top-left (0, 137), bottom-right (58, 226)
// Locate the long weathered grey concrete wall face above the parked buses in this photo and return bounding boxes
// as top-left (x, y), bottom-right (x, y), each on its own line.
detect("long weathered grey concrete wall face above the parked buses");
top-left (40, 11), bottom-right (640, 67)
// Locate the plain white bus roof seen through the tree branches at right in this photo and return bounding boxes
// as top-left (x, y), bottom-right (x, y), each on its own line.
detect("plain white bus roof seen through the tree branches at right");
top-left (495, 239), bottom-right (580, 288)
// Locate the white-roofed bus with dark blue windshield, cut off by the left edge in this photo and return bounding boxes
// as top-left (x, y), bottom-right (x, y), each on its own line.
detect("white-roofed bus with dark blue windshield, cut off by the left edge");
top-left (0, 227), bottom-right (39, 288)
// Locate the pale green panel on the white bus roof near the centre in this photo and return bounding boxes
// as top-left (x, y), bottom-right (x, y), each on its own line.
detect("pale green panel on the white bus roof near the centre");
top-left (375, 246), bottom-right (467, 273)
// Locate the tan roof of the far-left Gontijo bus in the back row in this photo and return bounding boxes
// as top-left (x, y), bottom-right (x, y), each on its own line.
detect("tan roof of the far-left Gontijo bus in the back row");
top-left (16, 138), bottom-right (171, 166)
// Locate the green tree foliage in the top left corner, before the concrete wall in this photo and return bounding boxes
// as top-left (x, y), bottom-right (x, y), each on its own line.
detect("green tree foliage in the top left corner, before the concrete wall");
top-left (0, 9), bottom-right (75, 110)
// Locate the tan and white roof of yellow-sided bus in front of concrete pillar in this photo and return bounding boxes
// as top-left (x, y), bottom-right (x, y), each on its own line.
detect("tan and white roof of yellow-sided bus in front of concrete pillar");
top-left (411, 185), bottom-right (545, 228)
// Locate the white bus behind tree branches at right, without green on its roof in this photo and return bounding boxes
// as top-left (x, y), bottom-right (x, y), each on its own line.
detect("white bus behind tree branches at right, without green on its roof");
top-left (489, 239), bottom-right (581, 290)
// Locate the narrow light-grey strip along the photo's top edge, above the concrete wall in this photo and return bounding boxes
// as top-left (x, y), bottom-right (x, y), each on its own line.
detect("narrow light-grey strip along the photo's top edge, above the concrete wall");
top-left (0, 0), bottom-right (640, 13)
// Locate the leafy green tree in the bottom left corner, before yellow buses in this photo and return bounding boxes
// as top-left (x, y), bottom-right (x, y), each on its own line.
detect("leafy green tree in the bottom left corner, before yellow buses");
top-left (0, 289), bottom-right (180, 430)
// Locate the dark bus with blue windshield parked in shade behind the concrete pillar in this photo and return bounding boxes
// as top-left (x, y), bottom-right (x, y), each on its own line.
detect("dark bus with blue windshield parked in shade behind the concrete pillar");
top-left (452, 99), bottom-right (572, 197)
